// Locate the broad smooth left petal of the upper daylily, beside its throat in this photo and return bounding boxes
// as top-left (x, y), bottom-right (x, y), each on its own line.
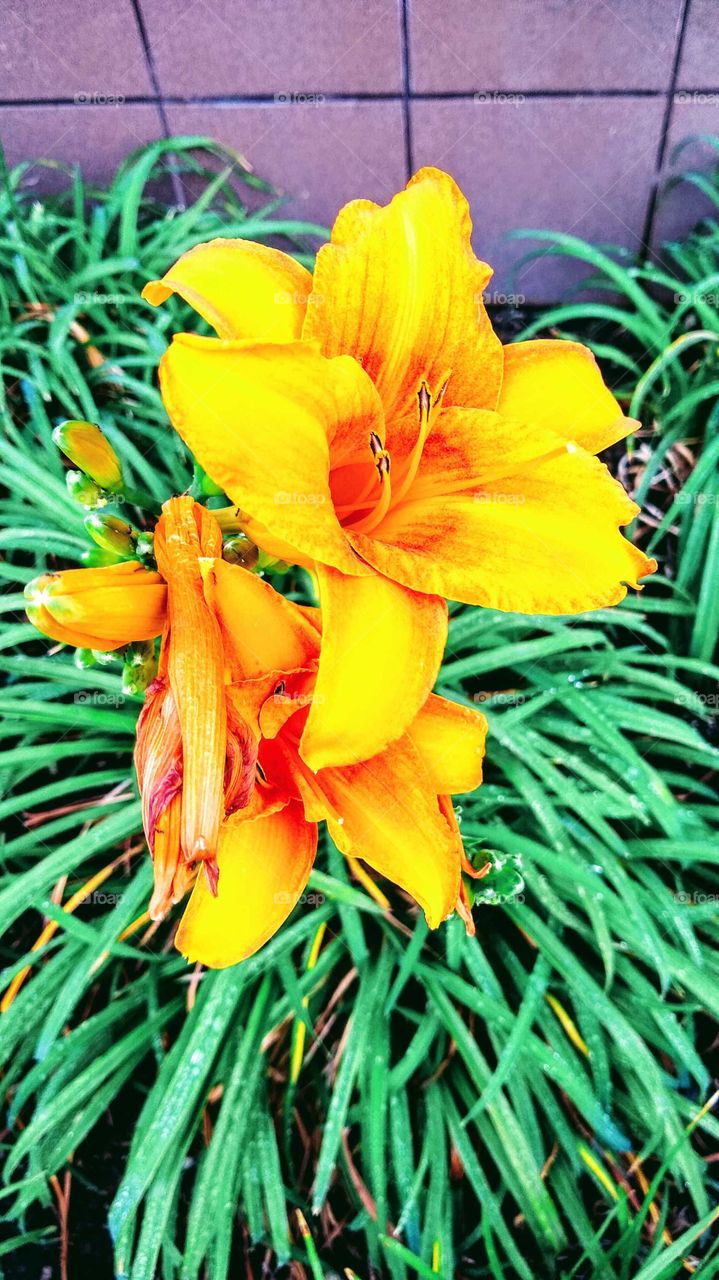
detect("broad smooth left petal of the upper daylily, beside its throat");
top-left (160, 334), bottom-right (383, 573)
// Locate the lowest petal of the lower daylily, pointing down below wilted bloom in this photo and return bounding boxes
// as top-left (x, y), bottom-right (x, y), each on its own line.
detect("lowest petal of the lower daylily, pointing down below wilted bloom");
top-left (175, 800), bottom-right (317, 969)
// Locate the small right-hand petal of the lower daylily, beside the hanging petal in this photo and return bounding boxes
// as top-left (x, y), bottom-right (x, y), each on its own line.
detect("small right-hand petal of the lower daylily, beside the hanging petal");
top-left (407, 694), bottom-right (487, 795)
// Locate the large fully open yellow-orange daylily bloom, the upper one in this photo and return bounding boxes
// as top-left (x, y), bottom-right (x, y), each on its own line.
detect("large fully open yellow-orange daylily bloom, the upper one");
top-left (143, 169), bottom-right (656, 769)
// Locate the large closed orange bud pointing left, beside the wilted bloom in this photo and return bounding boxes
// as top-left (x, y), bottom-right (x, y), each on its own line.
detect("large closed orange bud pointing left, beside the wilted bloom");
top-left (24, 561), bottom-right (168, 653)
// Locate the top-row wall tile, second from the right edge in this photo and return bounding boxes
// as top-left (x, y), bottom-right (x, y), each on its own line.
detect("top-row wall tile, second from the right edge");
top-left (409, 0), bottom-right (680, 92)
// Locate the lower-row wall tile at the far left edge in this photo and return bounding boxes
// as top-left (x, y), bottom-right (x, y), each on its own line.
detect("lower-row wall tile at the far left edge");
top-left (0, 104), bottom-right (162, 191)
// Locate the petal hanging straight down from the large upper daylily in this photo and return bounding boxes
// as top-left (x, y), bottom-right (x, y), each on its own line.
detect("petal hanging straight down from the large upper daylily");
top-left (301, 564), bottom-right (446, 769)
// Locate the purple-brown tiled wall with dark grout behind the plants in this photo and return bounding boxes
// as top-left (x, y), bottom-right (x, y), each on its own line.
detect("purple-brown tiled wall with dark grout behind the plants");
top-left (0, 0), bottom-right (719, 301)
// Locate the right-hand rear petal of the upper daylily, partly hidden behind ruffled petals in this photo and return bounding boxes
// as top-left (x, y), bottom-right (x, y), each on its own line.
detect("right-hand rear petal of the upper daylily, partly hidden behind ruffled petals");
top-left (498, 339), bottom-right (640, 453)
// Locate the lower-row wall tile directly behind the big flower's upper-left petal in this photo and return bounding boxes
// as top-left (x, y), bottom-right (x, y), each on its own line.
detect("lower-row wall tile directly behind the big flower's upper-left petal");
top-left (168, 102), bottom-right (404, 225)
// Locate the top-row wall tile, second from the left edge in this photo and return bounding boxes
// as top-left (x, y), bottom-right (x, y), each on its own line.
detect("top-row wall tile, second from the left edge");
top-left (142, 0), bottom-right (402, 97)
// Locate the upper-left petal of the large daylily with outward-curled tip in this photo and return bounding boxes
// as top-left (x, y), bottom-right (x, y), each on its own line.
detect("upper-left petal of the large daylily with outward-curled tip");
top-left (142, 239), bottom-right (312, 342)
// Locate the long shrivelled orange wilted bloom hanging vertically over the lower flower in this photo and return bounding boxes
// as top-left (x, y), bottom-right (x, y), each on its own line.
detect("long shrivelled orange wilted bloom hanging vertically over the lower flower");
top-left (155, 497), bottom-right (226, 861)
